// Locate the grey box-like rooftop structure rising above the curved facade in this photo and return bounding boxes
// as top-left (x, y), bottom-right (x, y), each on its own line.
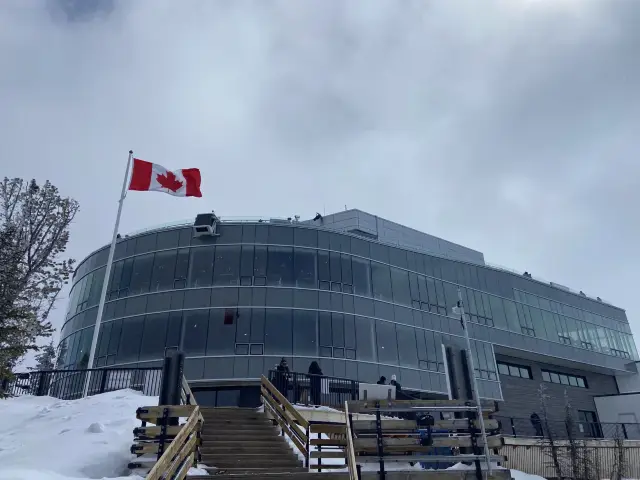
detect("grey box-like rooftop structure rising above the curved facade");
top-left (302, 209), bottom-right (484, 265)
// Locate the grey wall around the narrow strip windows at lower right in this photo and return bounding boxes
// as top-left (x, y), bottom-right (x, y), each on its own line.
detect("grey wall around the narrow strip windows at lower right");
top-left (496, 355), bottom-right (618, 420)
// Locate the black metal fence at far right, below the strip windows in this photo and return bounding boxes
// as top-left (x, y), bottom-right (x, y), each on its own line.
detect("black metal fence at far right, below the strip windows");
top-left (494, 416), bottom-right (640, 440)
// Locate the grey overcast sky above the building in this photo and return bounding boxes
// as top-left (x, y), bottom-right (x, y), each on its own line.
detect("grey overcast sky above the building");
top-left (0, 0), bottom-right (640, 364)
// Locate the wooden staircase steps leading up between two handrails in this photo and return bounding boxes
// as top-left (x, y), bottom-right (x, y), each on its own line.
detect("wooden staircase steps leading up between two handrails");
top-left (189, 407), bottom-right (320, 480)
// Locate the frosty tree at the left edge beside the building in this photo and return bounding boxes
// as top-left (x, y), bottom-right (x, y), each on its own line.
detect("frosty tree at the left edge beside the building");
top-left (0, 178), bottom-right (79, 388)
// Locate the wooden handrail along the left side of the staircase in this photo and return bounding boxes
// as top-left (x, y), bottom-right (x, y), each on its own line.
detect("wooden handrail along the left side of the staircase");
top-left (146, 405), bottom-right (202, 480)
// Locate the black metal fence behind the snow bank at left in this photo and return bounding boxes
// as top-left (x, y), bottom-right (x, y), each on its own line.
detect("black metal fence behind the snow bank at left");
top-left (0, 367), bottom-right (162, 400)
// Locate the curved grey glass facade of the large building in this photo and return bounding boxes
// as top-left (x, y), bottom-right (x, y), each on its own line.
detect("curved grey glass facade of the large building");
top-left (59, 223), bottom-right (638, 399)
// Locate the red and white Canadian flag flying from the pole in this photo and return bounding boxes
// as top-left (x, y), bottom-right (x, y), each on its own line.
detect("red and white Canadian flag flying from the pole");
top-left (129, 158), bottom-right (202, 197)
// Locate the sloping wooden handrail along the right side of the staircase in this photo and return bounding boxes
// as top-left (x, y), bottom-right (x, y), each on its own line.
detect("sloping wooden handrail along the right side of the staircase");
top-left (260, 375), bottom-right (309, 468)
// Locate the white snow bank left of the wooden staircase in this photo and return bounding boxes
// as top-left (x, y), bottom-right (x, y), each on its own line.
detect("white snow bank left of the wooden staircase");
top-left (0, 390), bottom-right (158, 480)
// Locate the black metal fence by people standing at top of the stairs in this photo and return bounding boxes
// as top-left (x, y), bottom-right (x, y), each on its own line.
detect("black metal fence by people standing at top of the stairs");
top-left (269, 370), bottom-right (360, 407)
